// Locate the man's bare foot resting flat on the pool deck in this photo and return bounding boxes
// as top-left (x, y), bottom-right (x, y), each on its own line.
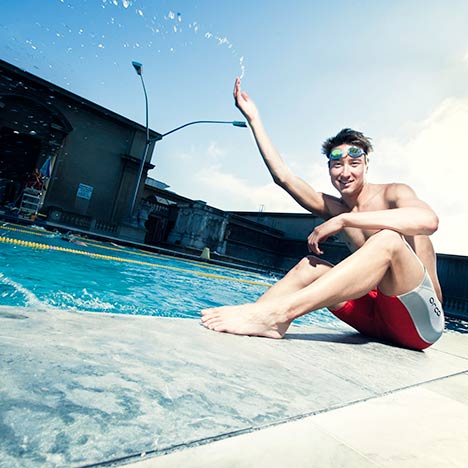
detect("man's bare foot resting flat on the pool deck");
top-left (201, 301), bottom-right (291, 338)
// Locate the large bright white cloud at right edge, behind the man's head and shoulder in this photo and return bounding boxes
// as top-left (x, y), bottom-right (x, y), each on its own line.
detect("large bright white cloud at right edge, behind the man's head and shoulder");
top-left (371, 98), bottom-right (468, 255)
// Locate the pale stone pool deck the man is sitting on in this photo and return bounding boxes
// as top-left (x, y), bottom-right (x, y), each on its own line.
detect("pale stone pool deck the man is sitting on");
top-left (0, 306), bottom-right (468, 468)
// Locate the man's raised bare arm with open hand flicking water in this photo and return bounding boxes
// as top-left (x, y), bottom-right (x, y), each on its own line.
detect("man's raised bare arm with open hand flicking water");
top-left (234, 78), bottom-right (330, 218)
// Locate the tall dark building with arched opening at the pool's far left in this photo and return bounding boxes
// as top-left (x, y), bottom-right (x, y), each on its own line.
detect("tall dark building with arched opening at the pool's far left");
top-left (0, 61), bottom-right (160, 241)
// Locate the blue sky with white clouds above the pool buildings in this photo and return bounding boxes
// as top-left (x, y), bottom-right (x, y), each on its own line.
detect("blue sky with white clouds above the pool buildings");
top-left (0, 0), bottom-right (468, 255)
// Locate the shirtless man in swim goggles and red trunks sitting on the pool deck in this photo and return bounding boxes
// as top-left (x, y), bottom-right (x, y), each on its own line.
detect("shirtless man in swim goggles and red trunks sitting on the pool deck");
top-left (202, 79), bottom-right (444, 349)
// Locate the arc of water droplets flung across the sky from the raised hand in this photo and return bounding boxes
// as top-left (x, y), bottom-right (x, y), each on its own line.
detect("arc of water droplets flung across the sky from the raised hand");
top-left (0, 0), bottom-right (246, 88)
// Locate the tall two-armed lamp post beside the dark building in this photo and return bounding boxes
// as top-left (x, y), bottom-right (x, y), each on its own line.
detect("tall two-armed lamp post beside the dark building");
top-left (128, 62), bottom-right (247, 222)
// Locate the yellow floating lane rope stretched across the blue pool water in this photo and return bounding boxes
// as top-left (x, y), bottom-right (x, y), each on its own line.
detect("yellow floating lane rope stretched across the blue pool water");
top-left (0, 237), bottom-right (271, 288)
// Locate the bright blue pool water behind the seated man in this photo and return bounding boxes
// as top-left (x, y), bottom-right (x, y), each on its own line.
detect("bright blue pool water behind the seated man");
top-left (0, 224), bottom-right (339, 326)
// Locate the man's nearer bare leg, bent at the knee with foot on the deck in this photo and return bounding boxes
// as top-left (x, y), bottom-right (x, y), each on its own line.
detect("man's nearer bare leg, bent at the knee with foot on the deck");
top-left (202, 230), bottom-right (424, 338)
